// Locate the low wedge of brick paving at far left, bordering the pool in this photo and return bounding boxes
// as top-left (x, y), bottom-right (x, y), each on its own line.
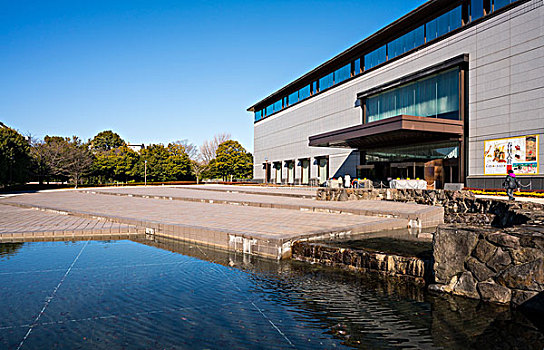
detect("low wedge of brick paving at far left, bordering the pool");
top-left (0, 203), bottom-right (137, 242)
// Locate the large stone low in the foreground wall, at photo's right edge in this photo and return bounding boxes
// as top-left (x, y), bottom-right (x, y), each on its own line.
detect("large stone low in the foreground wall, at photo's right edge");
top-left (497, 259), bottom-right (544, 292)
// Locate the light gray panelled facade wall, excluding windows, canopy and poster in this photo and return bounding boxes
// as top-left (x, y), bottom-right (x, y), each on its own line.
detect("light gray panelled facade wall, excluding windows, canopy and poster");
top-left (254, 0), bottom-right (544, 189)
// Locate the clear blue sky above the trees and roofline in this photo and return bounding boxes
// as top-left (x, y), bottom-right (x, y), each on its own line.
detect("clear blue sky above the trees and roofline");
top-left (0, 0), bottom-right (424, 150)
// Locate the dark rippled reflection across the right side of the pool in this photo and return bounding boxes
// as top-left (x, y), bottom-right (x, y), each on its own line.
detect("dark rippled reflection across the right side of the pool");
top-left (136, 237), bottom-right (544, 349)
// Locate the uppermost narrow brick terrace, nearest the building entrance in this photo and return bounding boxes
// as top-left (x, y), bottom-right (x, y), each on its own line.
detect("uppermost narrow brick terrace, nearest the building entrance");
top-left (86, 186), bottom-right (444, 227)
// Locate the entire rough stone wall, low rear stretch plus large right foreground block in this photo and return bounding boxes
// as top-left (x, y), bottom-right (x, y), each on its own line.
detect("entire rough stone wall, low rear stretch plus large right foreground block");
top-left (317, 188), bottom-right (544, 309)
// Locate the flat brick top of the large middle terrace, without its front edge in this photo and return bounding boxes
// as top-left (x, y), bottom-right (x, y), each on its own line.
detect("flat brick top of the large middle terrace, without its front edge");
top-left (4, 191), bottom-right (405, 237)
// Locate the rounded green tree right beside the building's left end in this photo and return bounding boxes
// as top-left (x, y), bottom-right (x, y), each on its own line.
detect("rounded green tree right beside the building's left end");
top-left (214, 140), bottom-right (253, 180)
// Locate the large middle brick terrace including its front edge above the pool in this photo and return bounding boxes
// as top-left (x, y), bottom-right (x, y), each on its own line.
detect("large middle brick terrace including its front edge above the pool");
top-left (0, 191), bottom-right (408, 258)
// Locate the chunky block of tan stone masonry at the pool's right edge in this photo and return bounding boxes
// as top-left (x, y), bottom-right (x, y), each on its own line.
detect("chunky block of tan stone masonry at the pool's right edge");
top-left (430, 225), bottom-right (544, 305)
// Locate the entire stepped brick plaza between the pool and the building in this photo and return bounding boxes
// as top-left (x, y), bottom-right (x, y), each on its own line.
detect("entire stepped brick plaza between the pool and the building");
top-left (0, 186), bottom-right (442, 258)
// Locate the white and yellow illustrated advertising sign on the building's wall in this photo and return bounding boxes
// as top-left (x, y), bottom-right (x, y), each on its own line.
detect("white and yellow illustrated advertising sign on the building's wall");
top-left (484, 135), bottom-right (539, 175)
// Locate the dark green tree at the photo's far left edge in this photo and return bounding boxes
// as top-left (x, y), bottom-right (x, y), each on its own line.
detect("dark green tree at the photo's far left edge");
top-left (0, 126), bottom-right (31, 185)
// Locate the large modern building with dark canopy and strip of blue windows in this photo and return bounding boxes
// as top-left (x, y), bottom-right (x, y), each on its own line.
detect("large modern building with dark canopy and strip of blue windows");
top-left (248, 0), bottom-right (544, 189)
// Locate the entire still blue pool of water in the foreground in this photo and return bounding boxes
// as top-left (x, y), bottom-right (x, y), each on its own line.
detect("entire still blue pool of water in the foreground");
top-left (0, 237), bottom-right (544, 349)
